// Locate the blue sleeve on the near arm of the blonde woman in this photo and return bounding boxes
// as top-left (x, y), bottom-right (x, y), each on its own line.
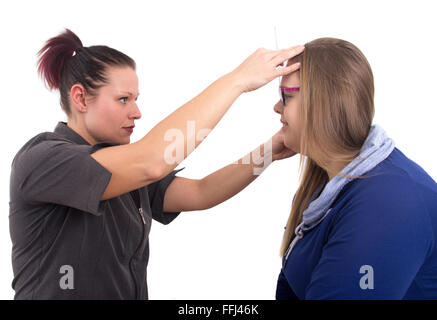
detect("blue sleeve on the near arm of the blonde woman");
top-left (305, 175), bottom-right (433, 299)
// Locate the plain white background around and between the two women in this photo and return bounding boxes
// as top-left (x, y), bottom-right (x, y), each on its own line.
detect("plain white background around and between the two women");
top-left (0, 0), bottom-right (437, 299)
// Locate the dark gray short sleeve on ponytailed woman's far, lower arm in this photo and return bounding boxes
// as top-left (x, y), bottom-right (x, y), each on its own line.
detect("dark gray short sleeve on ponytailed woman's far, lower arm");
top-left (147, 168), bottom-right (185, 224)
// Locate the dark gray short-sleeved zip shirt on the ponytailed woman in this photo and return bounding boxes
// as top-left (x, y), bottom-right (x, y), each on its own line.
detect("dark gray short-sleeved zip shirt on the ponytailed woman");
top-left (9, 122), bottom-right (182, 299)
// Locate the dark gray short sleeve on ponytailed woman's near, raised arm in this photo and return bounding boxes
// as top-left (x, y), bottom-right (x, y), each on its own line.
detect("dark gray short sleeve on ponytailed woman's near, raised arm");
top-left (12, 140), bottom-right (118, 215)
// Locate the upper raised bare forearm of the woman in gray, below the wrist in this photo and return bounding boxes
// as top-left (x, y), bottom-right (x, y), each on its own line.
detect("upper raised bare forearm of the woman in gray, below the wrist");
top-left (138, 73), bottom-right (242, 177)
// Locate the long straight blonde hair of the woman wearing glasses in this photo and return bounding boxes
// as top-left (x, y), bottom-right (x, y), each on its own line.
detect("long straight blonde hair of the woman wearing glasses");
top-left (281, 38), bottom-right (374, 256)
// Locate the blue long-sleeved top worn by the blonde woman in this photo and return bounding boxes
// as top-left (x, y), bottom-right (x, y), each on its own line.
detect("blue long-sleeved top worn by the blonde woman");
top-left (276, 148), bottom-right (437, 299)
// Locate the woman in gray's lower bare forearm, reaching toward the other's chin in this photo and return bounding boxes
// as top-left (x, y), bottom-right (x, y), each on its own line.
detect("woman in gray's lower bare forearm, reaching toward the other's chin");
top-left (195, 144), bottom-right (272, 210)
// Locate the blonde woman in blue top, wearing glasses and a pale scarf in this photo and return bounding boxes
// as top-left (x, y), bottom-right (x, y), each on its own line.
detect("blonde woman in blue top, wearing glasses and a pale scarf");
top-left (274, 38), bottom-right (437, 299)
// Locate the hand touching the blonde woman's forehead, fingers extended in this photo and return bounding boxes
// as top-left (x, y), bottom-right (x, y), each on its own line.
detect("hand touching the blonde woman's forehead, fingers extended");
top-left (231, 46), bottom-right (305, 92)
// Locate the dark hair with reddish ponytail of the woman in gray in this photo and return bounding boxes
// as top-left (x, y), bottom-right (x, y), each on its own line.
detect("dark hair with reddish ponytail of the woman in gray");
top-left (37, 29), bottom-right (136, 116)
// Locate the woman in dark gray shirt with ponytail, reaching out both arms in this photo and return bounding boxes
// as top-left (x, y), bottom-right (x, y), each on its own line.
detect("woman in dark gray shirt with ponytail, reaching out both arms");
top-left (9, 29), bottom-right (303, 299)
